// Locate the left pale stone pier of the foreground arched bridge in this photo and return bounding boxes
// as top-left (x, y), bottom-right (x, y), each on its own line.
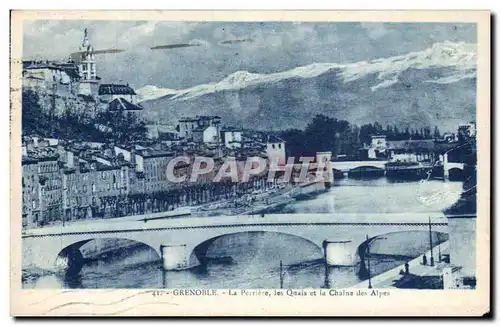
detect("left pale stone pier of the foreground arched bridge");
top-left (160, 245), bottom-right (200, 271)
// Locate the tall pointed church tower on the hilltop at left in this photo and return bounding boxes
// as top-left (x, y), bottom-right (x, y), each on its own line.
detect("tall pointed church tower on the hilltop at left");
top-left (78, 28), bottom-right (98, 95)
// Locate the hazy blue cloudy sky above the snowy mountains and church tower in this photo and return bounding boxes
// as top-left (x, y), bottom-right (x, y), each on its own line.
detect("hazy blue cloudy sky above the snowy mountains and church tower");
top-left (23, 20), bottom-right (476, 89)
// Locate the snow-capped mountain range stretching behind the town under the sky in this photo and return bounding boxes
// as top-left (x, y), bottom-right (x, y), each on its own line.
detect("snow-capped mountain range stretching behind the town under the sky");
top-left (136, 42), bottom-right (476, 131)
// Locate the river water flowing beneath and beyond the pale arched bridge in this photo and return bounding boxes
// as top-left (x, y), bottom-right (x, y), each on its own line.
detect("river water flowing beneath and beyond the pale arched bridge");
top-left (23, 178), bottom-right (462, 289)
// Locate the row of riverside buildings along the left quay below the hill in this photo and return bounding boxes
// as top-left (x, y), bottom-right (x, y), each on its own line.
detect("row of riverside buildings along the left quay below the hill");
top-left (22, 117), bottom-right (285, 227)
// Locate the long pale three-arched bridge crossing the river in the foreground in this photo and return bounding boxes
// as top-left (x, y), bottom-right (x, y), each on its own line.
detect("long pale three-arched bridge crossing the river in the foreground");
top-left (22, 213), bottom-right (448, 270)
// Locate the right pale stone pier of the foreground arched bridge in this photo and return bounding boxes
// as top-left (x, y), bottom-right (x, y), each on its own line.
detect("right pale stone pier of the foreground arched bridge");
top-left (323, 240), bottom-right (359, 266)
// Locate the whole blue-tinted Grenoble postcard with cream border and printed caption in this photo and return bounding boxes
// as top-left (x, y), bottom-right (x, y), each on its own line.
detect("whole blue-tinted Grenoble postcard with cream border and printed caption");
top-left (10, 11), bottom-right (490, 317)
